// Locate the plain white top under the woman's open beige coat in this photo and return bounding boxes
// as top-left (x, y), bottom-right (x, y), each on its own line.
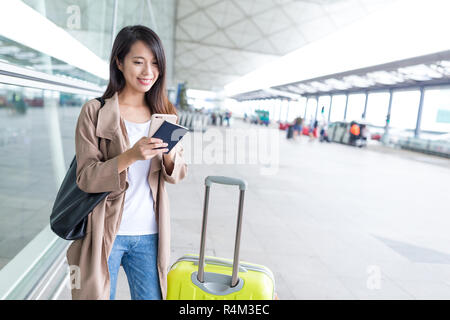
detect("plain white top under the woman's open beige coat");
top-left (117, 119), bottom-right (158, 235)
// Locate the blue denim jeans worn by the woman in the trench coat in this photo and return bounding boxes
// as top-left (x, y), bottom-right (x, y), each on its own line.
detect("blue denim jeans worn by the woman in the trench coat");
top-left (108, 233), bottom-right (162, 300)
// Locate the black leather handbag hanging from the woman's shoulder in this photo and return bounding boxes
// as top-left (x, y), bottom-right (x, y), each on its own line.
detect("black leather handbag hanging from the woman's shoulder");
top-left (50, 98), bottom-right (110, 240)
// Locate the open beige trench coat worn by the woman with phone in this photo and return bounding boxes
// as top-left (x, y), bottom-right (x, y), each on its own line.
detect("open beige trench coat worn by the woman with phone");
top-left (67, 92), bottom-right (187, 300)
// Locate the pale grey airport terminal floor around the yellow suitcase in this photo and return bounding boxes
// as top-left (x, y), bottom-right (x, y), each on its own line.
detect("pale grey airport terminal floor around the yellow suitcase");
top-left (60, 120), bottom-right (450, 299)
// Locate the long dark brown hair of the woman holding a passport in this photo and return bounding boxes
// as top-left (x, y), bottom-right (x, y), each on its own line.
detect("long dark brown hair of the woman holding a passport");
top-left (102, 25), bottom-right (177, 114)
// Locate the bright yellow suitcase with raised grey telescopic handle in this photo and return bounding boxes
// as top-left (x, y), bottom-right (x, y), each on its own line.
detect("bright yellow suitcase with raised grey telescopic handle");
top-left (167, 176), bottom-right (275, 300)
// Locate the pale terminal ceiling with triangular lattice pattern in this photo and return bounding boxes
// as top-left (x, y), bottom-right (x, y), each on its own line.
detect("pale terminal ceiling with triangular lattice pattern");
top-left (174, 0), bottom-right (392, 91)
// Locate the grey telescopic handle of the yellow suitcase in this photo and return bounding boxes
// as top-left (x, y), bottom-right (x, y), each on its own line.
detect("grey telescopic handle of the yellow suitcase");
top-left (197, 176), bottom-right (247, 287)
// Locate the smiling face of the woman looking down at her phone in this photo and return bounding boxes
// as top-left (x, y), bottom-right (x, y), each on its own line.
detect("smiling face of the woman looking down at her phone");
top-left (116, 40), bottom-right (159, 93)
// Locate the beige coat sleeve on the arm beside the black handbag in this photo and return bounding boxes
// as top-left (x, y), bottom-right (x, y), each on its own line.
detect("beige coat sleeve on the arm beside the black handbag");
top-left (75, 103), bottom-right (126, 193)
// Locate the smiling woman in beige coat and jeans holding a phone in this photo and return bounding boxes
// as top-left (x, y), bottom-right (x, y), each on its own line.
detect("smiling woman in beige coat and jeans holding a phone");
top-left (67, 25), bottom-right (187, 299)
